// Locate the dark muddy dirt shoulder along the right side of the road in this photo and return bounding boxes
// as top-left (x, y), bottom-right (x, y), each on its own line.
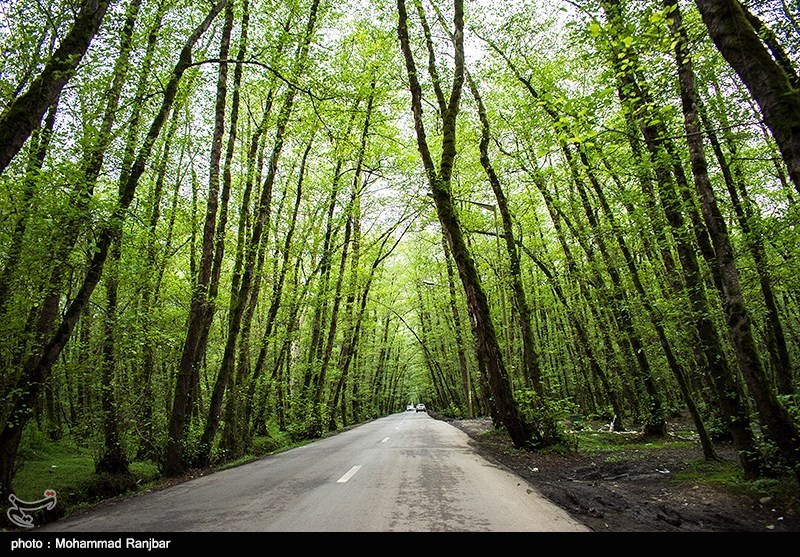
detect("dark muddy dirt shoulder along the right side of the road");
top-left (448, 419), bottom-right (800, 532)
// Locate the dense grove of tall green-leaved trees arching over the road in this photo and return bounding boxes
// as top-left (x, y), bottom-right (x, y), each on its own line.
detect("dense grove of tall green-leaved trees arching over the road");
top-left (0, 0), bottom-right (800, 500)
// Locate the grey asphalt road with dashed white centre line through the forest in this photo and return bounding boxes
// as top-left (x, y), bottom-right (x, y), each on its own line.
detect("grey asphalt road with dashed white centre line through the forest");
top-left (37, 412), bottom-right (590, 532)
